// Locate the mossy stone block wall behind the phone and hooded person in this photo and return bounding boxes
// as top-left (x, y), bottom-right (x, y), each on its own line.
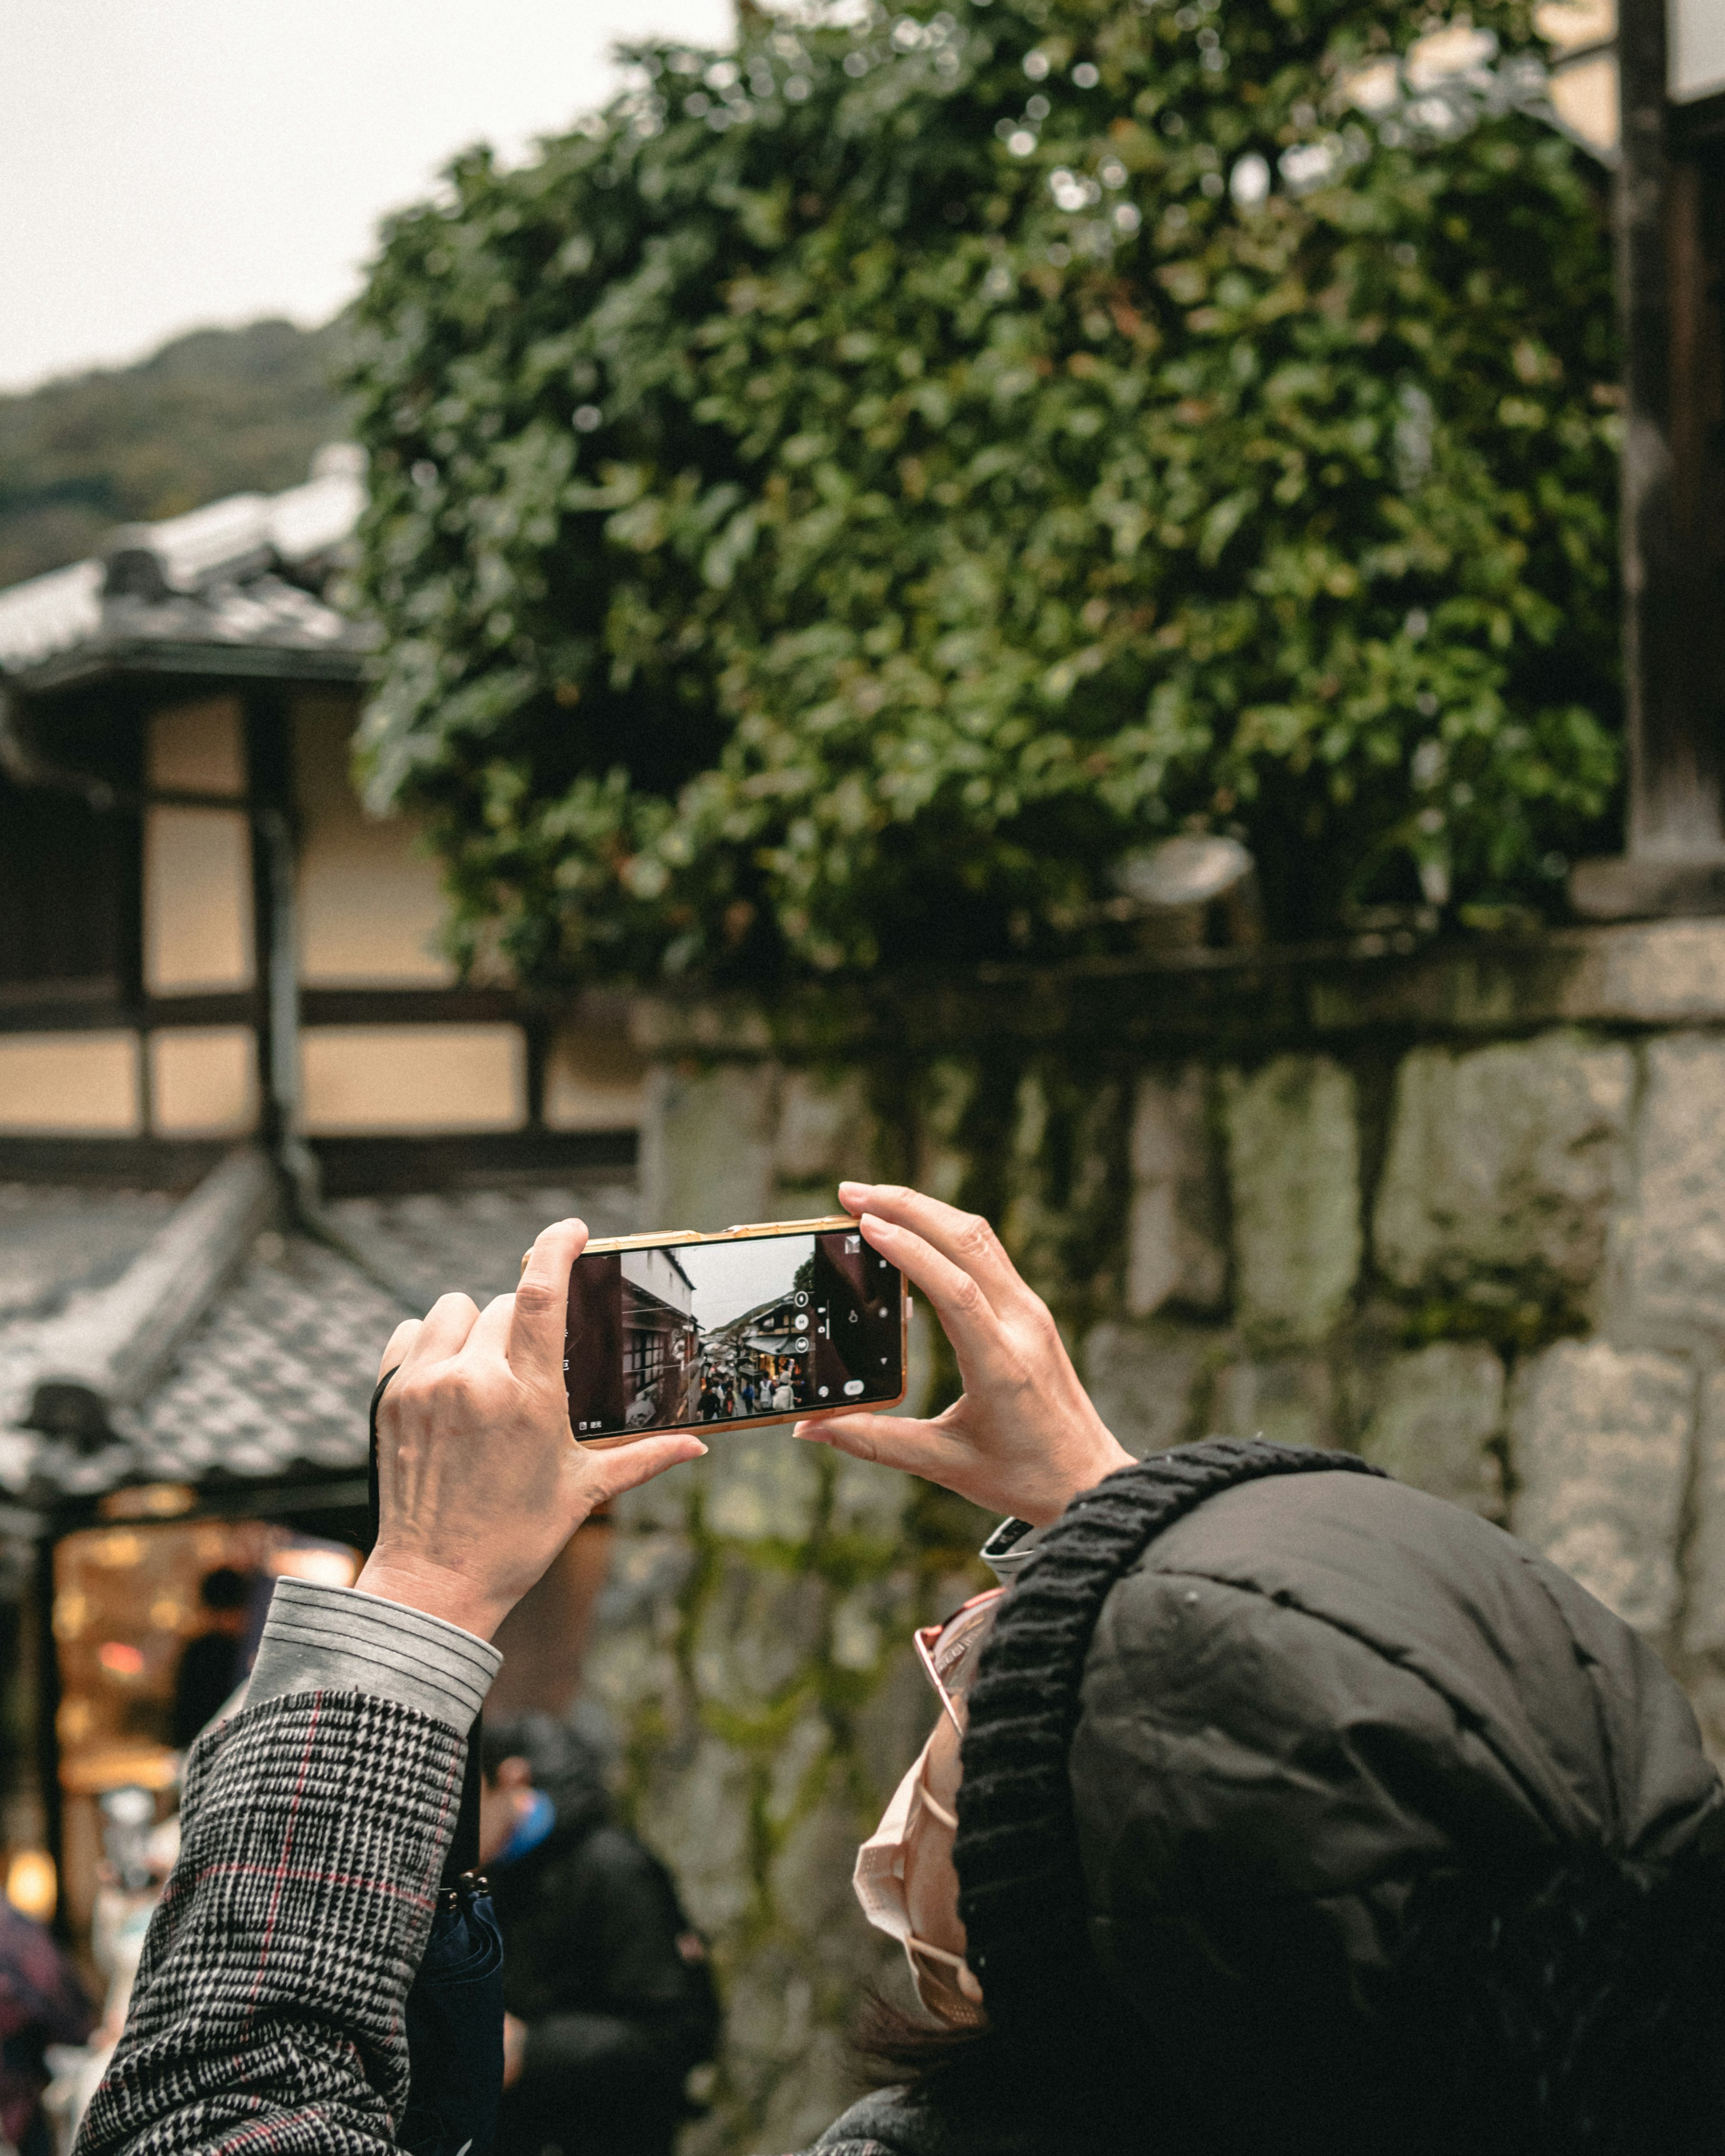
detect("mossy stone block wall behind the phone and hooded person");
top-left (588, 923), bottom-right (1725, 2152)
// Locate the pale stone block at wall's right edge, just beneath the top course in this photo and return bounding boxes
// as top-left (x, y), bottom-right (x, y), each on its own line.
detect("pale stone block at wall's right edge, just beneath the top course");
top-left (1609, 1033), bottom-right (1725, 1348)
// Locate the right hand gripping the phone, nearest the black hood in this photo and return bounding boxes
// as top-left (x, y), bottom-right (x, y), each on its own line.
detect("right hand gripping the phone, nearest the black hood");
top-left (796, 1184), bottom-right (1132, 1526)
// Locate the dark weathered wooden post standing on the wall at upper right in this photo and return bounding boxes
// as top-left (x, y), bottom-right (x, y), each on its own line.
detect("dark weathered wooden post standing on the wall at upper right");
top-left (1570, 0), bottom-right (1725, 919)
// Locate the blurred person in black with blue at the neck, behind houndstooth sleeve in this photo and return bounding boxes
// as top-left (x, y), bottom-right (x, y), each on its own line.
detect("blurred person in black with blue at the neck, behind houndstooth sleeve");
top-left (479, 1714), bottom-right (718, 2156)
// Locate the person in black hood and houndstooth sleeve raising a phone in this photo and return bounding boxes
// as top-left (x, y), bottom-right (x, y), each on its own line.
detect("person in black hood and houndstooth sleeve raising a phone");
top-left (80, 1184), bottom-right (1725, 2156)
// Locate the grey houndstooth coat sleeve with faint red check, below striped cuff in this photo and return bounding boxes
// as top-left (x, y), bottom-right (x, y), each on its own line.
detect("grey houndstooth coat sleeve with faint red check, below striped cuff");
top-left (75, 1692), bottom-right (466, 2156)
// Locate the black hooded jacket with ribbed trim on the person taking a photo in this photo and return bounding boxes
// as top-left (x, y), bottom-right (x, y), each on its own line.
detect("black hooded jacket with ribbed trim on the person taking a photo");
top-left (931, 1440), bottom-right (1725, 2156)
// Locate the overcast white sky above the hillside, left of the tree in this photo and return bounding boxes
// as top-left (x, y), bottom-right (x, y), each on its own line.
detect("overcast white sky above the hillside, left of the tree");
top-left (0, 0), bottom-right (733, 390)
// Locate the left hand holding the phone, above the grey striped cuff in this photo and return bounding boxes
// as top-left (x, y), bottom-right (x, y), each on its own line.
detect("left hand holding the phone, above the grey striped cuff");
top-left (356, 1220), bottom-right (707, 1639)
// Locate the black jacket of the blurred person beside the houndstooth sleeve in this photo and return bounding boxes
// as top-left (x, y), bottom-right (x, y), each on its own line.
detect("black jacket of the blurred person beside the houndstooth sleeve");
top-left (490, 1803), bottom-right (718, 2156)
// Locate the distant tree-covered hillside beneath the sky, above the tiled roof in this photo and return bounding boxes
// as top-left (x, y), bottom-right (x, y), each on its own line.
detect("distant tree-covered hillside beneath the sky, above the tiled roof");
top-left (0, 321), bottom-right (347, 587)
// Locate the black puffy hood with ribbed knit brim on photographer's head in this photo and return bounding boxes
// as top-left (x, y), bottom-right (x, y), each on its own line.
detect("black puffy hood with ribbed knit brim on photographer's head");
top-left (955, 1440), bottom-right (1725, 2147)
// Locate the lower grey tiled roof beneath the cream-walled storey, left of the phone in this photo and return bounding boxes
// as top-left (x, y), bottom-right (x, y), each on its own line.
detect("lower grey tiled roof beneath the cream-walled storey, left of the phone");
top-left (0, 1175), bottom-right (634, 1505)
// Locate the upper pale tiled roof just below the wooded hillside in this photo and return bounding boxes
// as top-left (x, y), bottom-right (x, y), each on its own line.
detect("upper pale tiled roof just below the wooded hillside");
top-left (0, 444), bottom-right (369, 677)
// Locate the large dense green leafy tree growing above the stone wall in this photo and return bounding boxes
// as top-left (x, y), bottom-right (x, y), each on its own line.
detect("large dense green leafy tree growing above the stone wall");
top-left (354, 0), bottom-right (1617, 979)
